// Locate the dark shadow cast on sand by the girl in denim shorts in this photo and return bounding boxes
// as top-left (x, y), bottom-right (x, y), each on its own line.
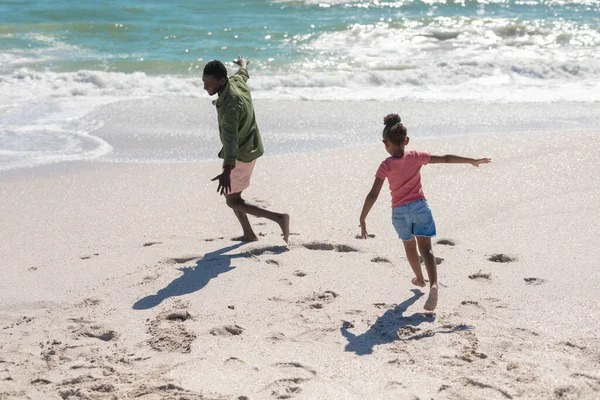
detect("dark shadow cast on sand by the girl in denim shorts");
top-left (341, 289), bottom-right (435, 356)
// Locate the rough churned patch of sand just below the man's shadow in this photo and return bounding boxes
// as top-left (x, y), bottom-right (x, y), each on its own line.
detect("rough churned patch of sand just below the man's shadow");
top-left (147, 309), bottom-right (196, 353)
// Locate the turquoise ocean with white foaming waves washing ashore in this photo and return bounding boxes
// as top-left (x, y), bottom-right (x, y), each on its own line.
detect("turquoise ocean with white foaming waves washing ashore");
top-left (0, 0), bottom-right (600, 170)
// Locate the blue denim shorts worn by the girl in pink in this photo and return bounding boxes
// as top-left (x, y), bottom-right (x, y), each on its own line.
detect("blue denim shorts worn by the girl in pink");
top-left (392, 200), bottom-right (436, 240)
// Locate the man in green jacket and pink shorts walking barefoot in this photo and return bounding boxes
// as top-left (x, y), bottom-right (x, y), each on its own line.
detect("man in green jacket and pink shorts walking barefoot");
top-left (202, 56), bottom-right (290, 243)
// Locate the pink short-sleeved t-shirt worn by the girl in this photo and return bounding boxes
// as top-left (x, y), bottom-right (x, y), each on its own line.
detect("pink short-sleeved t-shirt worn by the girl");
top-left (375, 151), bottom-right (431, 208)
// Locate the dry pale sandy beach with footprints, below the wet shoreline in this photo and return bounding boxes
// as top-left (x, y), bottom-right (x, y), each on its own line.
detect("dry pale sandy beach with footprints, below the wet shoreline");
top-left (0, 115), bottom-right (600, 400)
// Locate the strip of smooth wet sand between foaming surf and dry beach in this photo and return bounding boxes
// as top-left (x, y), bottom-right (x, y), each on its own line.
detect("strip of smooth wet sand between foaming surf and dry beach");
top-left (0, 96), bottom-right (600, 174)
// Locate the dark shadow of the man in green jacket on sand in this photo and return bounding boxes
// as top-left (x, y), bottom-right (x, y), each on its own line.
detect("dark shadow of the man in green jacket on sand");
top-left (133, 243), bottom-right (249, 310)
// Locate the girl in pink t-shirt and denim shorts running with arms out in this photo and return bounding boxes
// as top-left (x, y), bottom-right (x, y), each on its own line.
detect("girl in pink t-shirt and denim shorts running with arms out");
top-left (360, 114), bottom-right (491, 311)
